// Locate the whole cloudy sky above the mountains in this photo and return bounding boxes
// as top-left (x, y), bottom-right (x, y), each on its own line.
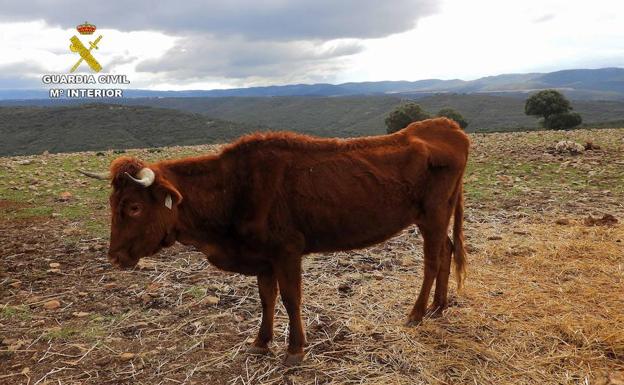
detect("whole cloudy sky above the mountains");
top-left (0, 0), bottom-right (624, 90)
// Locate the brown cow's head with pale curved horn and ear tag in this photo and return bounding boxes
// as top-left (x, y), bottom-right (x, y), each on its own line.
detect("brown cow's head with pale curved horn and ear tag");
top-left (85, 157), bottom-right (182, 268)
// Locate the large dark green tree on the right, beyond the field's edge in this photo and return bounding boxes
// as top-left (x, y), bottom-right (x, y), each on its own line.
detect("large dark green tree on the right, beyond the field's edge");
top-left (524, 90), bottom-right (583, 130)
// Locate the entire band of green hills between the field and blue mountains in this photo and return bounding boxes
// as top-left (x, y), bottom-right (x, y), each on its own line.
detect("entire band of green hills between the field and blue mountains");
top-left (0, 94), bottom-right (624, 156)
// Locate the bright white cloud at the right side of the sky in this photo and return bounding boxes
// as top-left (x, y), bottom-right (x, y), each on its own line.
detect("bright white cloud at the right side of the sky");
top-left (340, 0), bottom-right (624, 81)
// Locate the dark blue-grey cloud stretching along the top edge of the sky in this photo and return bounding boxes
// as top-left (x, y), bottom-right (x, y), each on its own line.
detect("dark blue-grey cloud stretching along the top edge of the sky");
top-left (0, 0), bottom-right (440, 41)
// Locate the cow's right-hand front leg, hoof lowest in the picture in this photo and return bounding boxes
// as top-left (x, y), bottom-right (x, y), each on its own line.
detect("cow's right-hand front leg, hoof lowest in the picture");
top-left (274, 256), bottom-right (306, 366)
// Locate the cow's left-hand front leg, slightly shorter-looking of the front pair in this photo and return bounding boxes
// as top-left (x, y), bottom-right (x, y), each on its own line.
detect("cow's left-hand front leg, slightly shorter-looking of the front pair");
top-left (249, 272), bottom-right (277, 354)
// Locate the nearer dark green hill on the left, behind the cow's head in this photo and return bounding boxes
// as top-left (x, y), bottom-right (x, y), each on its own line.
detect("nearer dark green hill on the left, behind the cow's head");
top-left (0, 104), bottom-right (262, 156)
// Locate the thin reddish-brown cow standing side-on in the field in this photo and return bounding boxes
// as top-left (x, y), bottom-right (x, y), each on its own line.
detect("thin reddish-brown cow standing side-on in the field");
top-left (80, 118), bottom-right (469, 364)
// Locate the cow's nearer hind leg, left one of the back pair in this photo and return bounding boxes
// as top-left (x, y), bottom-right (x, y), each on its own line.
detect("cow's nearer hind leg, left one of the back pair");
top-left (407, 213), bottom-right (449, 326)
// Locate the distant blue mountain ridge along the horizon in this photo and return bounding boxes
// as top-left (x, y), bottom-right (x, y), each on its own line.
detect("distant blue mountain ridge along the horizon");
top-left (0, 67), bottom-right (624, 100)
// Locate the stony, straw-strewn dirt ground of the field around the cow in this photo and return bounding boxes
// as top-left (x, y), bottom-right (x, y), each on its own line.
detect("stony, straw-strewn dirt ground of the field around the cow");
top-left (0, 129), bottom-right (624, 385)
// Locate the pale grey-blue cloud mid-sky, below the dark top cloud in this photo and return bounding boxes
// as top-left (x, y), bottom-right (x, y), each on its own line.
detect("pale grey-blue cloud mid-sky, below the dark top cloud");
top-left (137, 35), bottom-right (362, 82)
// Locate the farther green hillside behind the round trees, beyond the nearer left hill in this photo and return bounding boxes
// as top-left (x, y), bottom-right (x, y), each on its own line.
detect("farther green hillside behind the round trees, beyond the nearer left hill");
top-left (120, 94), bottom-right (624, 136)
